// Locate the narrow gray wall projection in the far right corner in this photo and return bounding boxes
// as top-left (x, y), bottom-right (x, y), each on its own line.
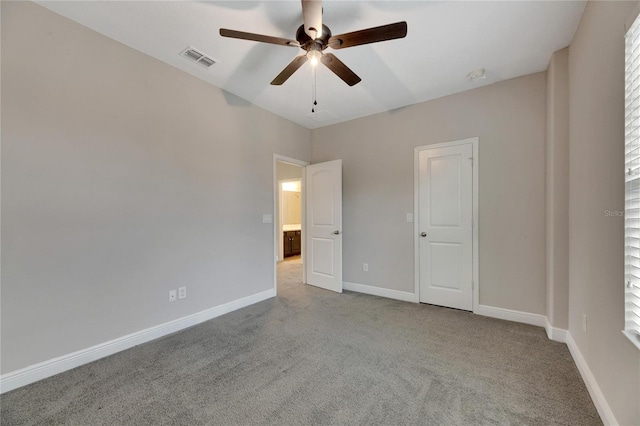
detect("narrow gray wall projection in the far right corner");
top-left (545, 48), bottom-right (569, 330)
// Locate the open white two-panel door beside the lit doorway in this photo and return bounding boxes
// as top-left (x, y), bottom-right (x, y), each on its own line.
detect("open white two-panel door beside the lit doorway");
top-left (305, 160), bottom-right (342, 293)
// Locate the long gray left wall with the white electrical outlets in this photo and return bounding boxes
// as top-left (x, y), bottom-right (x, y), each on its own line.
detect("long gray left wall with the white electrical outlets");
top-left (1, 2), bottom-right (310, 373)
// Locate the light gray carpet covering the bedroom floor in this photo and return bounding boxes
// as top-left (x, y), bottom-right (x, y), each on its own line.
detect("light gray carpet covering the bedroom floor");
top-left (0, 261), bottom-right (601, 426)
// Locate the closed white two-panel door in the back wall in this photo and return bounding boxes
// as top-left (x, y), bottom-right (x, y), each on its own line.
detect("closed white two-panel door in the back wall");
top-left (418, 143), bottom-right (473, 311)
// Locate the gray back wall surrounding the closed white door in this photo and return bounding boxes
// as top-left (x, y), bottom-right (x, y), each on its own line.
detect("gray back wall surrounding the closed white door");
top-left (312, 73), bottom-right (546, 314)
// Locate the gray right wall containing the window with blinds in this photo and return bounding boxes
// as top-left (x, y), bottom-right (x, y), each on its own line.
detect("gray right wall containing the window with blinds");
top-left (569, 2), bottom-right (640, 425)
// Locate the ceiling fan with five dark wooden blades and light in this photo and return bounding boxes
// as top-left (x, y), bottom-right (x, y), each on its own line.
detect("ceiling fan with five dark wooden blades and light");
top-left (220, 0), bottom-right (407, 86)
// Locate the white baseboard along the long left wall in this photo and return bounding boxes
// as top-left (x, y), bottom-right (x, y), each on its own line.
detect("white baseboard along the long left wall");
top-left (0, 289), bottom-right (275, 394)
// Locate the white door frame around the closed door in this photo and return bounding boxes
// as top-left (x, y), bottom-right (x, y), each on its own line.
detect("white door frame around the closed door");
top-left (413, 137), bottom-right (480, 313)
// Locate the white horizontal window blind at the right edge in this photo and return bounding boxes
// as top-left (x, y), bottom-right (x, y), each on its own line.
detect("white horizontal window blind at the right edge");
top-left (624, 15), bottom-right (640, 335)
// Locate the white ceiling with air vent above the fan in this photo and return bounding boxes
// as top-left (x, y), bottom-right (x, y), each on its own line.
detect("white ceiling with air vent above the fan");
top-left (37, 0), bottom-right (585, 129)
